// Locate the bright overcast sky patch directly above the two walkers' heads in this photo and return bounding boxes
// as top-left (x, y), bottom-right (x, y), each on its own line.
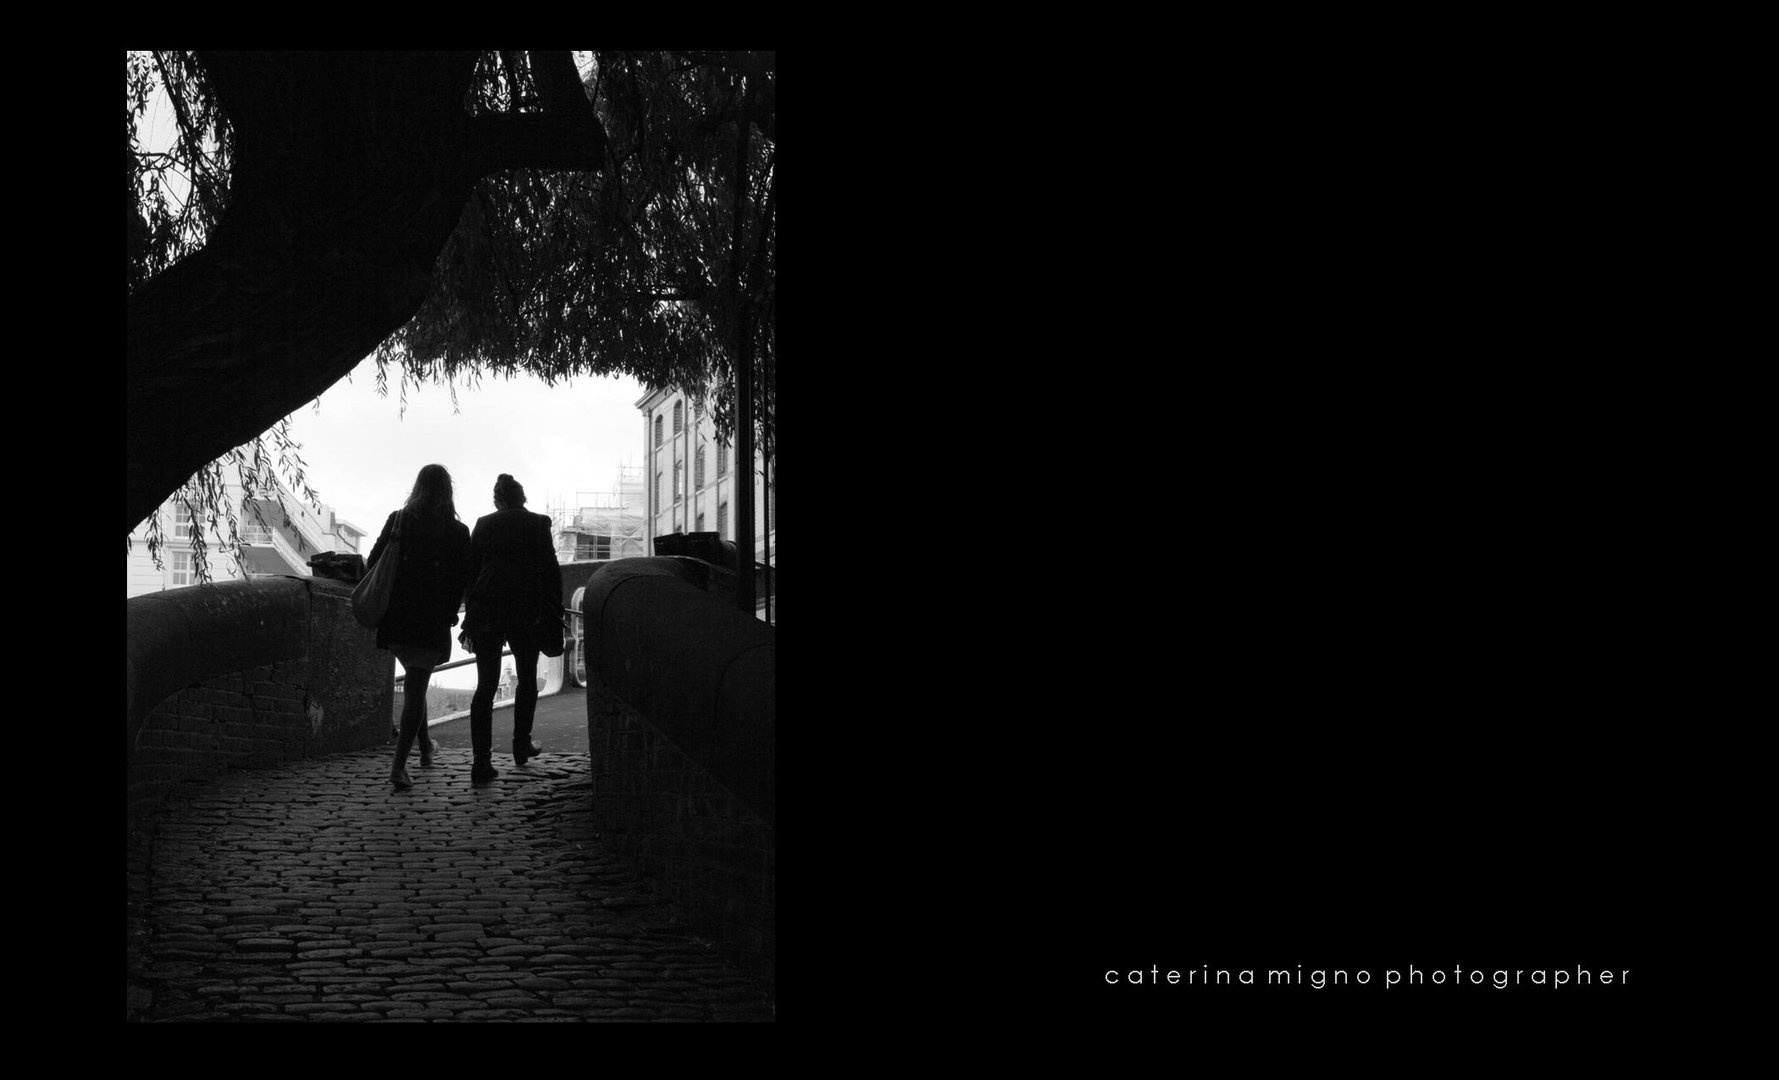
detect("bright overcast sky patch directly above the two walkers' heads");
top-left (284, 359), bottom-right (646, 555)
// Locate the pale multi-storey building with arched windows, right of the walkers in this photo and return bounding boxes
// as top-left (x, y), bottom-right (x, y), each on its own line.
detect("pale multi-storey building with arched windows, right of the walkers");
top-left (637, 390), bottom-right (777, 621)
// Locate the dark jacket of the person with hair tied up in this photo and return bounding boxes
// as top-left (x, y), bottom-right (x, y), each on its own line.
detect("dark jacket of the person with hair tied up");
top-left (463, 507), bottom-right (562, 633)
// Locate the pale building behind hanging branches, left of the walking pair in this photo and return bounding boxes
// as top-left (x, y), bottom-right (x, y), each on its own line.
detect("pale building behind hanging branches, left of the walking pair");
top-left (128, 484), bottom-right (366, 596)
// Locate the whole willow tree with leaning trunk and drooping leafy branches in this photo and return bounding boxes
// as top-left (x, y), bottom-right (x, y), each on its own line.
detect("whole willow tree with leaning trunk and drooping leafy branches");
top-left (126, 52), bottom-right (776, 576)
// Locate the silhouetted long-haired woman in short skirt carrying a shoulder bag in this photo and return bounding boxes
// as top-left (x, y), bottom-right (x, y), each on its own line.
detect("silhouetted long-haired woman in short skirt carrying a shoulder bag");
top-left (365, 464), bottom-right (470, 788)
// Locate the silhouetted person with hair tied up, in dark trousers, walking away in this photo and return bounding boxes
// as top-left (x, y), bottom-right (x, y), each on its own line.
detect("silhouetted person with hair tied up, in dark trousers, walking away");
top-left (463, 473), bottom-right (562, 783)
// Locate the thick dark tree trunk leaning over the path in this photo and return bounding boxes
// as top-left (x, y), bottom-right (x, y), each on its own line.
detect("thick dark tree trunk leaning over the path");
top-left (125, 52), bottom-right (603, 528)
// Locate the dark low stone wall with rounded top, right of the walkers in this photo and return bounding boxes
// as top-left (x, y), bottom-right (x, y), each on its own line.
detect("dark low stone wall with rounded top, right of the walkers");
top-left (584, 559), bottom-right (777, 979)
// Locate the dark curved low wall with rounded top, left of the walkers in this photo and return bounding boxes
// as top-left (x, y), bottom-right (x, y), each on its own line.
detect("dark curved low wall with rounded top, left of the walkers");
top-left (126, 576), bottom-right (395, 833)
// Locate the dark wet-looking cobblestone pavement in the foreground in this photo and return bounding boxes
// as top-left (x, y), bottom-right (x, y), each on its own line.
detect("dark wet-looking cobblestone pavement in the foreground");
top-left (128, 747), bottom-right (776, 1023)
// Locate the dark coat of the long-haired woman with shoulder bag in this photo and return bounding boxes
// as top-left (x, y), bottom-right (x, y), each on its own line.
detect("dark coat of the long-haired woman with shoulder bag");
top-left (365, 511), bottom-right (470, 657)
